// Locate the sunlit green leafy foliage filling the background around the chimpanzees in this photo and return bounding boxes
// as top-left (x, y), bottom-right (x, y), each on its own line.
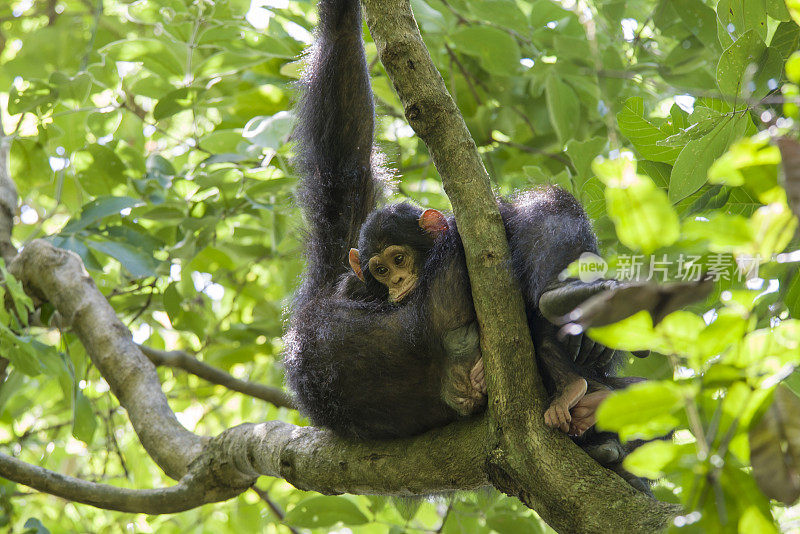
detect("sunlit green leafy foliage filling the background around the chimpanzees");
top-left (0, 0), bottom-right (800, 533)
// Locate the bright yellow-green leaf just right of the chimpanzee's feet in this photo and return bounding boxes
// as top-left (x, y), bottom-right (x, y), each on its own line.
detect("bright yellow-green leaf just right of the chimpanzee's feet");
top-left (597, 381), bottom-right (685, 440)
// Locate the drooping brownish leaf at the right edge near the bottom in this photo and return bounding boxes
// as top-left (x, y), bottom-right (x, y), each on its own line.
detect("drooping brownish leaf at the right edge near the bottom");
top-left (749, 385), bottom-right (800, 504)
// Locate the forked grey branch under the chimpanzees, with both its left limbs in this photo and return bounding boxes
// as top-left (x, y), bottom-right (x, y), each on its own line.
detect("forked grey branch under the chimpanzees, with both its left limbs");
top-left (0, 247), bottom-right (491, 513)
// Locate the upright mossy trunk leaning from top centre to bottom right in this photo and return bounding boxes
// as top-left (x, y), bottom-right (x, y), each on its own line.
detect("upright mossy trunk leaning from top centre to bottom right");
top-left (362, 0), bottom-right (676, 532)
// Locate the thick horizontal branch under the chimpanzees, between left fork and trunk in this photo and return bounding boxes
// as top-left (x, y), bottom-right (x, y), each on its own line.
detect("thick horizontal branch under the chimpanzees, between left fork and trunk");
top-left (209, 418), bottom-right (491, 495)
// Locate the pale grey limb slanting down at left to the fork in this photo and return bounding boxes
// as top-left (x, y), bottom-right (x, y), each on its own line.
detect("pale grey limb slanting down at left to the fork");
top-left (10, 240), bottom-right (204, 479)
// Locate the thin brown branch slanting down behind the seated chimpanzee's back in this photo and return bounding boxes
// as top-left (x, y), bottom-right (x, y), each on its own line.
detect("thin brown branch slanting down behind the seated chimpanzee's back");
top-left (139, 345), bottom-right (295, 408)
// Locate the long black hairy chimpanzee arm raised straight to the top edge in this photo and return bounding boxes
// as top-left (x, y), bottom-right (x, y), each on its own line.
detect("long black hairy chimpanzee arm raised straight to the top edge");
top-left (294, 0), bottom-right (384, 301)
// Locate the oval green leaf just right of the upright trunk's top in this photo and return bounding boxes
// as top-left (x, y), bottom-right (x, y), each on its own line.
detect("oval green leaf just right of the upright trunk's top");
top-left (450, 26), bottom-right (521, 76)
